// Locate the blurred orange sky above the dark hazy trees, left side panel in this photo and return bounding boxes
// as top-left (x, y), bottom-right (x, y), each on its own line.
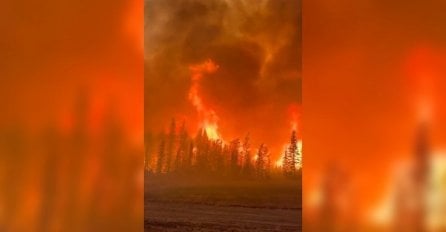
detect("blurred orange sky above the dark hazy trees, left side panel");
top-left (0, 0), bottom-right (143, 140)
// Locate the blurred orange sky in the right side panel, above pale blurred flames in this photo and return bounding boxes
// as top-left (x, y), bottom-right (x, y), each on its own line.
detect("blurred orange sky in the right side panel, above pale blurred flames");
top-left (303, 0), bottom-right (446, 221)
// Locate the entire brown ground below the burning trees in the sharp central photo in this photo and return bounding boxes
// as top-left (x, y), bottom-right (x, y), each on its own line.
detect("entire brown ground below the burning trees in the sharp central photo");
top-left (144, 178), bottom-right (301, 232)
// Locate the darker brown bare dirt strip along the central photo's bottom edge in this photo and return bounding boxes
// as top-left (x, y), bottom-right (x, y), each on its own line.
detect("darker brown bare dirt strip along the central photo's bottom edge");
top-left (144, 202), bottom-right (301, 232)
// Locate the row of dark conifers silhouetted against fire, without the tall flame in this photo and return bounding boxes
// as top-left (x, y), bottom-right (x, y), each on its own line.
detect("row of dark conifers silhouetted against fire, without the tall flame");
top-left (145, 119), bottom-right (301, 179)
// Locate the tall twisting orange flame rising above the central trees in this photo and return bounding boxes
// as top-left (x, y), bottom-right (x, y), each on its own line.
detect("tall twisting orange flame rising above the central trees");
top-left (189, 60), bottom-right (221, 140)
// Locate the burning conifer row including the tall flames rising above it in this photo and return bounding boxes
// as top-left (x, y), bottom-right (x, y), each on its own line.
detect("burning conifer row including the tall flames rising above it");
top-left (146, 59), bottom-right (300, 178)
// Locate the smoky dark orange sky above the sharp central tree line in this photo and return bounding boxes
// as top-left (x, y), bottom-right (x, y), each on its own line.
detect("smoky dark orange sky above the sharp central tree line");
top-left (145, 0), bottom-right (301, 156)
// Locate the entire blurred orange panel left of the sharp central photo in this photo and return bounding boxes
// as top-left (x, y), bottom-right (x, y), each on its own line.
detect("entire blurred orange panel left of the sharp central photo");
top-left (0, 0), bottom-right (144, 231)
